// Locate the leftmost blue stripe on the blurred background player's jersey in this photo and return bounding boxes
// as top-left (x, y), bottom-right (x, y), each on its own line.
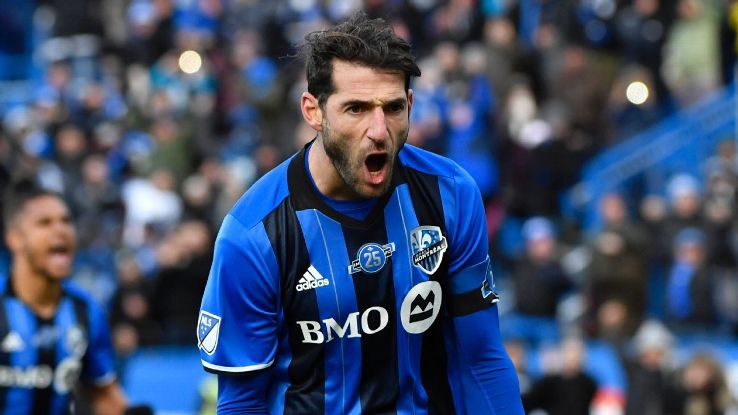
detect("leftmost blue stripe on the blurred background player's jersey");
top-left (4, 298), bottom-right (38, 413)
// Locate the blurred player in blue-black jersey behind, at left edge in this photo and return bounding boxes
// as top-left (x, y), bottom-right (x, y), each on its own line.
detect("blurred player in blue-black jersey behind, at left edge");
top-left (0, 180), bottom-right (126, 414)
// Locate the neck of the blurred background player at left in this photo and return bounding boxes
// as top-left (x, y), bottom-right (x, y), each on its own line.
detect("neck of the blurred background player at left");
top-left (9, 261), bottom-right (62, 318)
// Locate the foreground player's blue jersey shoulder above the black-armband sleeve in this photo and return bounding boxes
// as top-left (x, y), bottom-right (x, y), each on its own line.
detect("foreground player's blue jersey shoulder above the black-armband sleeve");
top-left (400, 144), bottom-right (477, 190)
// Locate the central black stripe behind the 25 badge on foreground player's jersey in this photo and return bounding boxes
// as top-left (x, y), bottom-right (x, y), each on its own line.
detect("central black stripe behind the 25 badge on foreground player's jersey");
top-left (343, 220), bottom-right (400, 414)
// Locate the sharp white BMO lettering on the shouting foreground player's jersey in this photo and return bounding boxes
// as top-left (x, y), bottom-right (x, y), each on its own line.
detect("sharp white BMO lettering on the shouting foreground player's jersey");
top-left (296, 307), bottom-right (389, 344)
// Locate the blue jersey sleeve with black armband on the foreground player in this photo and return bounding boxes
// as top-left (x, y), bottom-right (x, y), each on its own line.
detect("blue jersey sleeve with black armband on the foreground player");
top-left (443, 167), bottom-right (498, 316)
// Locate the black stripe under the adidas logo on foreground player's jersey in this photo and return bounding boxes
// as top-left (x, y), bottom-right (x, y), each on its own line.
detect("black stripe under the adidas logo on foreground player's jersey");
top-left (264, 198), bottom-right (325, 414)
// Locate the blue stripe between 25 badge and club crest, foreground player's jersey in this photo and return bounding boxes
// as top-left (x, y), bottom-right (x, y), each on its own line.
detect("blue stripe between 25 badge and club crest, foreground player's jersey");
top-left (384, 185), bottom-right (428, 415)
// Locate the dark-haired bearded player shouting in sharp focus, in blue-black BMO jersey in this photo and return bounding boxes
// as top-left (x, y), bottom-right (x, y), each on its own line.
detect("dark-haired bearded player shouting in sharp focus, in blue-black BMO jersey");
top-left (197, 13), bottom-right (523, 415)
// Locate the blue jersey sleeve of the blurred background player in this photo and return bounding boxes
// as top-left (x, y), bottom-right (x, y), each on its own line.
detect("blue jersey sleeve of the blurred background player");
top-left (81, 300), bottom-right (116, 386)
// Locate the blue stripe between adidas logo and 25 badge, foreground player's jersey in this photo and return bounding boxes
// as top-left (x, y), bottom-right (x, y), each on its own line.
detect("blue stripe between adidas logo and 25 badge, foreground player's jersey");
top-left (296, 209), bottom-right (361, 414)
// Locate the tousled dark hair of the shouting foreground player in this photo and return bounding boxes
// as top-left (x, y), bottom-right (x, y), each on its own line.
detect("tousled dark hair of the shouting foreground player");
top-left (300, 11), bottom-right (420, 106)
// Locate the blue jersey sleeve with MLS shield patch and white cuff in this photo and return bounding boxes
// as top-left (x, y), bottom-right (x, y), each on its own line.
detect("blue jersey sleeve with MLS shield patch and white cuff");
top-left (197, 215), bottom-right (279, 374)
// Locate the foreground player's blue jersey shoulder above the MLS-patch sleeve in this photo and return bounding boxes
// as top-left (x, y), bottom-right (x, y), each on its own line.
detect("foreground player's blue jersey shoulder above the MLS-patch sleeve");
top-left (229, 156), bottom-right (294, 229)
